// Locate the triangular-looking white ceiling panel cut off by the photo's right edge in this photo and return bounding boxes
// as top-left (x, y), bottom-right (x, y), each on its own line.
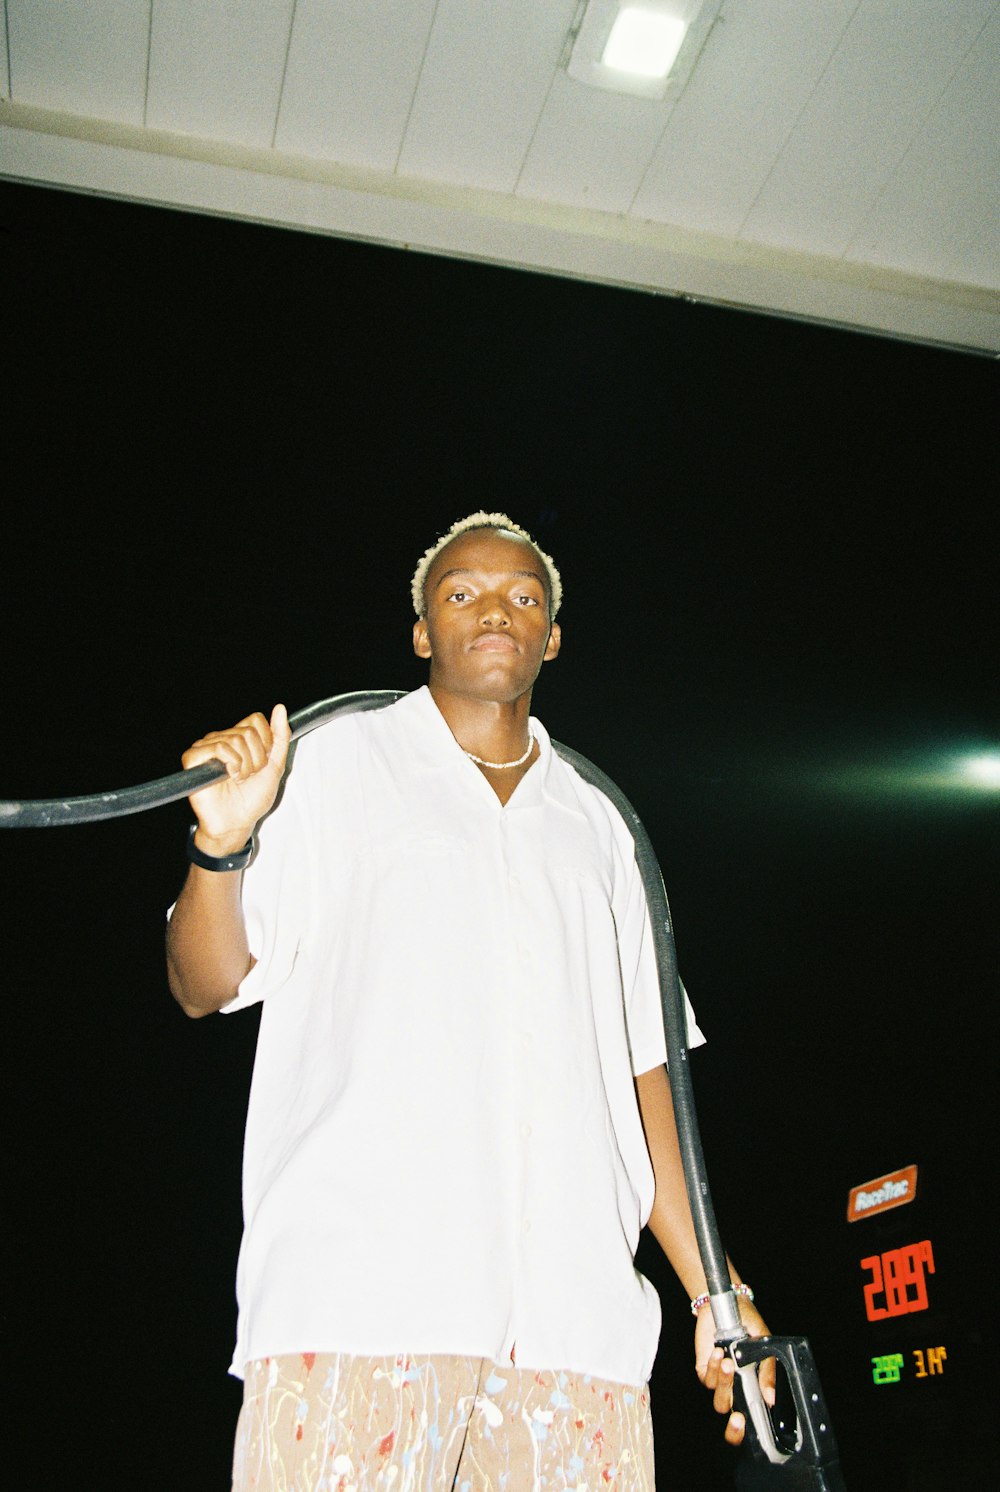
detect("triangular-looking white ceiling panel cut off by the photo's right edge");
top-left (848, 13), bottom-right (1000, 285)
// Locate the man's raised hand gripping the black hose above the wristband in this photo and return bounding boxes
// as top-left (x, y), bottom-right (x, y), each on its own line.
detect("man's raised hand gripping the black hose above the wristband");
top-left (181, 704), bottom-right (291, 856)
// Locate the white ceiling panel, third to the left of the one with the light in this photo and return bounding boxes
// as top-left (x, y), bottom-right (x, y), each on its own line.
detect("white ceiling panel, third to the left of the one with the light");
top-left (146, 0), bottom-right (294, 145)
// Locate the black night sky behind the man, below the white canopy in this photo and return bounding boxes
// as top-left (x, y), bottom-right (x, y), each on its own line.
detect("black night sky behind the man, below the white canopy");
top-left (0, 185), bottom-right (1000, 1492)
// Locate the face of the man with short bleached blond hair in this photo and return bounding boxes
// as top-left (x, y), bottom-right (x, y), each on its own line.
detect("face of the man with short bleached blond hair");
top-left (413, 528), bottom-right (560, 704)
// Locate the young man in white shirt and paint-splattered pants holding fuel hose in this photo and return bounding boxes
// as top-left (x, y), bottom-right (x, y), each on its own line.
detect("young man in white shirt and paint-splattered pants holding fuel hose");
top-left (167, 513), bottom-right (772, 1492)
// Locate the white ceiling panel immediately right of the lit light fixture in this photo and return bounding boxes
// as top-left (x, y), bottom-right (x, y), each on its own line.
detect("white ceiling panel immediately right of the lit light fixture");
top-left (631, 0), bottom-right (858, 233)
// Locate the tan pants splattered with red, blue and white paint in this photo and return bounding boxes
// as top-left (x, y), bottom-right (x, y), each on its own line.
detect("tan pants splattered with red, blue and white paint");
top-left (233, 1352), bottom-right (655, 1492)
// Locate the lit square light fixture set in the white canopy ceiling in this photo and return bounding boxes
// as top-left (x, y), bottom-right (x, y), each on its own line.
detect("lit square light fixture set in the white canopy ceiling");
top-left (566, 0), bottom-right (722, 98)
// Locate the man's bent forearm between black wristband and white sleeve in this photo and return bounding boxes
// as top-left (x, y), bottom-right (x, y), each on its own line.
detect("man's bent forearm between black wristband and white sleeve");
top-left (167, 865), bottom-right (254, 1016)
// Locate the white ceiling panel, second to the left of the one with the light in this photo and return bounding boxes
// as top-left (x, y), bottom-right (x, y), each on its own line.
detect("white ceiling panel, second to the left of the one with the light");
top-left (275, 0), bottom-right (434, 170)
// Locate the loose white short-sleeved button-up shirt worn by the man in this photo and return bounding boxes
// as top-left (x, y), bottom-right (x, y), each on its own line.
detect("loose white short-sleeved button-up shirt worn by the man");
top-left (225, 689), bottom-right (701, 1383)
